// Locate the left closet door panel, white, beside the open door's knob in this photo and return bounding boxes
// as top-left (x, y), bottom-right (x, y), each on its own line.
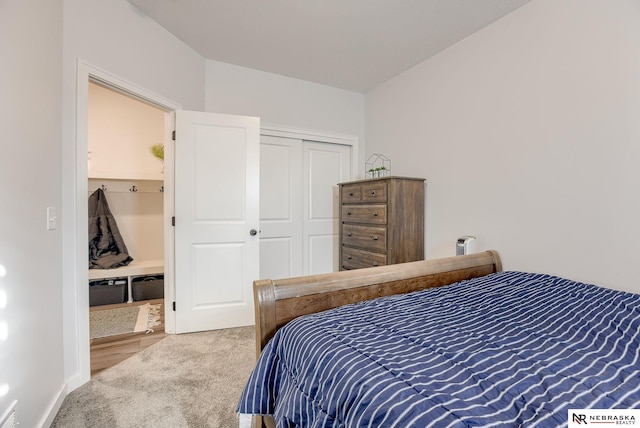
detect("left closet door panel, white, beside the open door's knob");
top-left (260, 135), bottom-right (303, 279)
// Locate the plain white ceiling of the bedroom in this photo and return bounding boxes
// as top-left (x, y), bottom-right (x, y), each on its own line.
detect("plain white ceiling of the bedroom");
top-left (128, 0), bottom-right (531, 93)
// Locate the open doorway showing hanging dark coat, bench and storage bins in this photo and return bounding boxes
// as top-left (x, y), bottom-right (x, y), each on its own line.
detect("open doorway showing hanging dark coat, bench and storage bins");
top-left (87, 81), bottom-right (165, 376)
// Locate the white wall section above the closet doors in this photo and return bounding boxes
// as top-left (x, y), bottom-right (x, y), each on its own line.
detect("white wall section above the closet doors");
top-left (205, 60), bottom-right (364, 174)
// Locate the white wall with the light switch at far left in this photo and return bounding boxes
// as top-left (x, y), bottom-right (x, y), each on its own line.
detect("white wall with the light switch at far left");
top-left (0, 0), bottom-right (64, 427)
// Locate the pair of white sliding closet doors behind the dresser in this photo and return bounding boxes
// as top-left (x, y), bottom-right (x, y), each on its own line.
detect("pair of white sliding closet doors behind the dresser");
top-left (260, 135), bottom-right (351, 278)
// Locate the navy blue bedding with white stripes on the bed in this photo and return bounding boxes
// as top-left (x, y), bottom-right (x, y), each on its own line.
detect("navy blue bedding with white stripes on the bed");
top-left (238, 272), bottom-right (640, 428)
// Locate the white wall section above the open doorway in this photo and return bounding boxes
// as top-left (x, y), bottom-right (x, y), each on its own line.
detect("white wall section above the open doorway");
top-left (64, 0), bottom-right (205, 110)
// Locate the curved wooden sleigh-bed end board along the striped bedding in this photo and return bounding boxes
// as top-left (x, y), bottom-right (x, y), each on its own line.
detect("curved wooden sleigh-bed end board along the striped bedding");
top-left (253, 251), bottom-right (502, 354)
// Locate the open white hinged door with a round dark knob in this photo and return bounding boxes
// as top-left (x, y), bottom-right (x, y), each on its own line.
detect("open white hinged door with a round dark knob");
top-left (174, 111), bottom-right (260, 333)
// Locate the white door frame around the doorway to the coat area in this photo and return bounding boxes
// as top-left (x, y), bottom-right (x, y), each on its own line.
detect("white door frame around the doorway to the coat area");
top-left (74, 59), bottom-right (182, 389)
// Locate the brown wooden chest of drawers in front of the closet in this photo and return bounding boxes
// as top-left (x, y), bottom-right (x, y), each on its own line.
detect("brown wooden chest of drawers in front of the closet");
top-left (339, 177), bottom-right (425, 270)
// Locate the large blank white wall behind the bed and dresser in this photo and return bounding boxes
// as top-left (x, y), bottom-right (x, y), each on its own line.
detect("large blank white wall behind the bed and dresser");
top-left (366, 0), bottom-right (640, 292)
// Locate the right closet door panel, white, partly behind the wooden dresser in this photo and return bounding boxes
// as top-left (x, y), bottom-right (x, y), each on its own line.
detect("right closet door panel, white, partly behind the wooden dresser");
top-left (302, 141), bottom-right (351, 275)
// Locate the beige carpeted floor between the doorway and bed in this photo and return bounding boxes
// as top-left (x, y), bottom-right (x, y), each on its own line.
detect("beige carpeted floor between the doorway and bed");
top-left (51, 327), bottom-right (256, 428)
